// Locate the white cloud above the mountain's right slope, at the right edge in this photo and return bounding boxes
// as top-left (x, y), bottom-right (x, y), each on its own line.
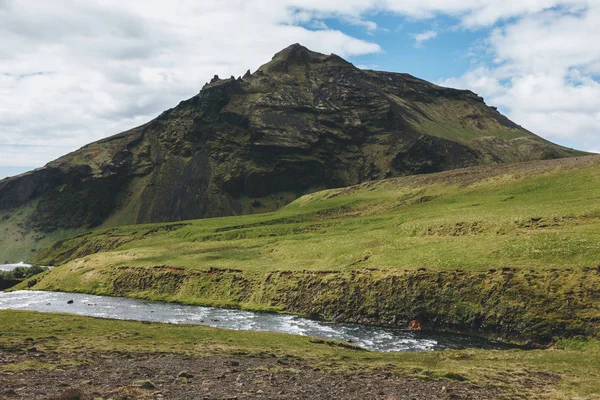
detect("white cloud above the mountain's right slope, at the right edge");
top-left (439, 2), bottom-right (600, 151)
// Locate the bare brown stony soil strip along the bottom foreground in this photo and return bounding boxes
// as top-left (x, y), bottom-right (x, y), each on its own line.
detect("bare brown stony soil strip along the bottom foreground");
top-left (0, 351), bottom-right (511, 400)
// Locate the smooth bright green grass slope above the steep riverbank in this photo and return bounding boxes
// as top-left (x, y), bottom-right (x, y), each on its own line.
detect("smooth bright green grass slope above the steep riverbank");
top-left (33, 157), bottom-right (600, 272)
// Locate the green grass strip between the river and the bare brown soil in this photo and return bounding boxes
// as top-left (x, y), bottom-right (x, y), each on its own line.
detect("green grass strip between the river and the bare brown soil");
top-left (0, 311), bottom-right (600, 399)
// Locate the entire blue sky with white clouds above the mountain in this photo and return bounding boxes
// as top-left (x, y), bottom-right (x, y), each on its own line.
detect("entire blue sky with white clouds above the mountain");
top-left (0, 0), bottom-right (600, 179)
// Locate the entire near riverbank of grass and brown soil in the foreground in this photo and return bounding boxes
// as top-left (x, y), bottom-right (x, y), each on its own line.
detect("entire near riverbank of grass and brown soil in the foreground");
top-left (0, 311), bottom-right (600, 400)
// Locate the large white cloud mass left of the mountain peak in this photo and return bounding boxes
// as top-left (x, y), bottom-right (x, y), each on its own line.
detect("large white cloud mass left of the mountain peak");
top-left (0, 0), bottom-right (381, 170)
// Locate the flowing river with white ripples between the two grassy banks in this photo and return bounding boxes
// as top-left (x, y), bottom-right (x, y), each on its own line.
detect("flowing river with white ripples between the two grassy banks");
top-left (0, 291), bottom-right (506, 352)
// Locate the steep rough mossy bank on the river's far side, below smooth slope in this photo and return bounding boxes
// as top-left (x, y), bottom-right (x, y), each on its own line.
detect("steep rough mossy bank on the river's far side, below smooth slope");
top-left (16, 260), bottom-right (600, 346)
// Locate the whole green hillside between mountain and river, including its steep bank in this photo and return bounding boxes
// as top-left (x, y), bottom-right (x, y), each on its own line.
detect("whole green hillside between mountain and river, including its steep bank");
top-left (21, 157), bottom-right (600, 344)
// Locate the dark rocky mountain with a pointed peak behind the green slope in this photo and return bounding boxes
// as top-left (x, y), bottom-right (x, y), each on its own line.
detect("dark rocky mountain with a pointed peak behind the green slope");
top-left (0, 44), bottom-right (584, 261)
